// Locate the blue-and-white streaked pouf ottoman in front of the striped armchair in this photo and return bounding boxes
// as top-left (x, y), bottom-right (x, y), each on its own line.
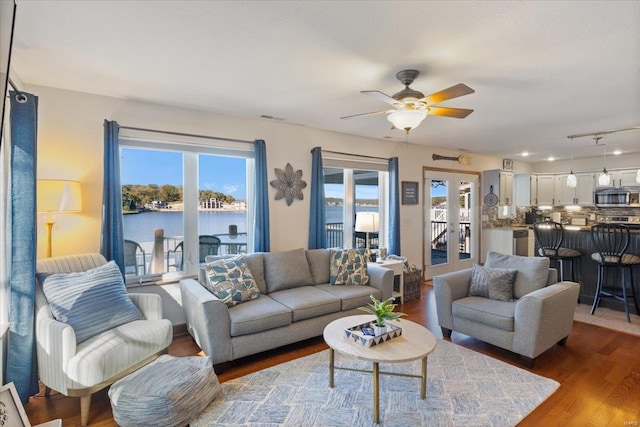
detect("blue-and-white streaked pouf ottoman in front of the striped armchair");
top-left (109, 355), bottom-right (222, 427)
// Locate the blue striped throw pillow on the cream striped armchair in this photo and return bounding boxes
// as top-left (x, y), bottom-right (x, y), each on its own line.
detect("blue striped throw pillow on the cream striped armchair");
top-left (38, 261), bottom-right (143, 344)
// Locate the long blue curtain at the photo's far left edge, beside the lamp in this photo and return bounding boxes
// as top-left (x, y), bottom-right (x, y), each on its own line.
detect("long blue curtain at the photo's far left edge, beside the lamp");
top-left (6, 92), bottom-right (38, 404)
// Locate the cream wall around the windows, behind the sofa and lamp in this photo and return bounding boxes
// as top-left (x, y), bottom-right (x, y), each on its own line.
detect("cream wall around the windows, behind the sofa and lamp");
top-left (32, 86), bottom-right (508, 265)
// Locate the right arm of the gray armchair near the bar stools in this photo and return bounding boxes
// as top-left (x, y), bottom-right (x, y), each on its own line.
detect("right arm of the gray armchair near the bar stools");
top-left (513, 282), bottom-right (580, 359)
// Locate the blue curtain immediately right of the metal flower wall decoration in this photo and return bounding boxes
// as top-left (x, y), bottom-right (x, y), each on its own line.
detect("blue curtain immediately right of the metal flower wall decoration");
top-left (309, 147), bottom-right (327, 249)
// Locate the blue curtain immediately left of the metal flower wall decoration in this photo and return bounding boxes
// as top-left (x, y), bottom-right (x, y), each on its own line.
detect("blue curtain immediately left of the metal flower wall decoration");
top-left (253, 139), bottom-right (271, 252)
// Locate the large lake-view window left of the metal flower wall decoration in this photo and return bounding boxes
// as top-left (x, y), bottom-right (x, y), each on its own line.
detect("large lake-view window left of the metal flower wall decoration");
top-left (120, 138), bottom-right (254, 283)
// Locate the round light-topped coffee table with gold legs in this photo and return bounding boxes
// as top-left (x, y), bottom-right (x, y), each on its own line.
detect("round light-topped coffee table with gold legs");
top-left (322, 315), bottom-right (436, 424)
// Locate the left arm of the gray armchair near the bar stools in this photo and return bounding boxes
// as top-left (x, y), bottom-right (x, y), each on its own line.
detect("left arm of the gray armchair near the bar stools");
top-left (433, 268), bottom-right (471, 330)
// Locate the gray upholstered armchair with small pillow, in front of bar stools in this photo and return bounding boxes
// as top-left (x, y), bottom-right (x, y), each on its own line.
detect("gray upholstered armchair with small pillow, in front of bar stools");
top-left (433, 252), bottom-right (580, 367)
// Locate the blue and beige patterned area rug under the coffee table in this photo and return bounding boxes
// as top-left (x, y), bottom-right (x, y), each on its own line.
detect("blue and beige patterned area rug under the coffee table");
top-left (190, 340), bottom-right (560, 427)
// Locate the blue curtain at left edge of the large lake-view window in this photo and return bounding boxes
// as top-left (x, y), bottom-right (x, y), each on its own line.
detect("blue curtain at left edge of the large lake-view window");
top-left (100, 120), bottom-right (124, 275)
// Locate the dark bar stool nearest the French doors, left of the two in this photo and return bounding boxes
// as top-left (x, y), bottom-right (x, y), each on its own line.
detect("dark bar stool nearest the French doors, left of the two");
top-left (533, 221), bottom-right (582, 282)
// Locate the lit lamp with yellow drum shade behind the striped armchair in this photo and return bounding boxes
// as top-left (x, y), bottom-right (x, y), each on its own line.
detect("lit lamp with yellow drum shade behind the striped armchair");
top-left (37, 179), bottom-right (82, 258)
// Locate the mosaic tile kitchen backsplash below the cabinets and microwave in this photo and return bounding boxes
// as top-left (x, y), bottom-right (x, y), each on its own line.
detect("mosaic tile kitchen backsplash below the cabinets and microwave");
top-left (482, 206), bottom-right (640, 228)
